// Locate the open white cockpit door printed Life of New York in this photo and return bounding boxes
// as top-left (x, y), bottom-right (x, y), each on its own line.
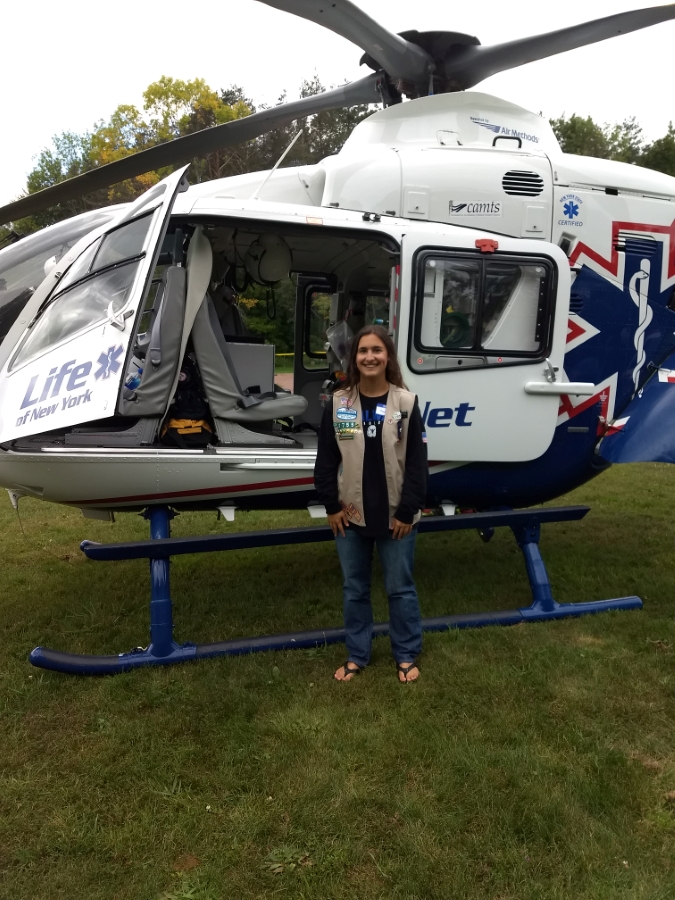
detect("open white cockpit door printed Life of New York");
top-left (0, 166), bottom-right (187, 442)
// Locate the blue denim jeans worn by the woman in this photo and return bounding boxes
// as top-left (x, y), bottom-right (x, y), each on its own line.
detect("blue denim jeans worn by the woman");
top-left (335, 525), bottom-right (422, 666)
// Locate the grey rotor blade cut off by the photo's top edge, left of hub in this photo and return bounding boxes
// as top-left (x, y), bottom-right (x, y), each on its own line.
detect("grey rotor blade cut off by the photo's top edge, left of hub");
top-left (254, 0), bottom-right (433, 84)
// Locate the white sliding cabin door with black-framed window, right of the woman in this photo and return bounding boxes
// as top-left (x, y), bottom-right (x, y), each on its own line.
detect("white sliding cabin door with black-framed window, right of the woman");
top-left (398, 230), bottom-right (572, 462)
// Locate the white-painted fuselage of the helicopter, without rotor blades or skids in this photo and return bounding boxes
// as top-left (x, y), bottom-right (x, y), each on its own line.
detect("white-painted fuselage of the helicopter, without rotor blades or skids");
top-left (0, 93), bottom-right (675, 515)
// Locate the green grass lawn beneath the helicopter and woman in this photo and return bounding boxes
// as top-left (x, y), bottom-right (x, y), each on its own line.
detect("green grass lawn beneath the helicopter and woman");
top-left (0, 465), bottom-right (675, 900)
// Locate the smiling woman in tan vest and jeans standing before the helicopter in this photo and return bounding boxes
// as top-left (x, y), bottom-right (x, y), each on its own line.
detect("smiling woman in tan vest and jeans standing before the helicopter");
top-left (314, 325), bottom-right (428, 682)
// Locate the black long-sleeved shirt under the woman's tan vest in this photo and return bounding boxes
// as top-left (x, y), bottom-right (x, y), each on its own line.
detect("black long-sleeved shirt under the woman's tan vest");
top-left (314, 386), bottom-right (429, 537)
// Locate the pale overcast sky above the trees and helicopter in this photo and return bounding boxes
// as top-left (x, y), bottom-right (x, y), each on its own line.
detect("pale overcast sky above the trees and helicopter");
top-left (0, 0), bottom-right (675, 204)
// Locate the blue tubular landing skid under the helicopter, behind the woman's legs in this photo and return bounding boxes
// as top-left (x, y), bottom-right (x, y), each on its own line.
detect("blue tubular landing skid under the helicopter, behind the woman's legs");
top-left (30, 506), bottom-right (642, 675)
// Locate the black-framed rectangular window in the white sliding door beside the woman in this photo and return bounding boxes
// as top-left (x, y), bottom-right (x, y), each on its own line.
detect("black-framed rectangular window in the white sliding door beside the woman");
top-left (411, 252), bottom-right (554, 371)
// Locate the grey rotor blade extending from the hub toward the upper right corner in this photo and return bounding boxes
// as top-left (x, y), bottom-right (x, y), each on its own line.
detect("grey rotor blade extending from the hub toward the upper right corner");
top-left (445, 3), bottom-right (675, 89)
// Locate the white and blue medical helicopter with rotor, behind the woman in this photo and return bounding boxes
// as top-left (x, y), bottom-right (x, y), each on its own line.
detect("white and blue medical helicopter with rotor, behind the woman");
top-left (0, 0), bottom-right (675, 668)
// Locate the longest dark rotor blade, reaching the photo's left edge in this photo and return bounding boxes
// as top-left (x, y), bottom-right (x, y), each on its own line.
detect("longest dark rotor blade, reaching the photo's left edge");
top-left (0, 72), bottom-right (382, 225)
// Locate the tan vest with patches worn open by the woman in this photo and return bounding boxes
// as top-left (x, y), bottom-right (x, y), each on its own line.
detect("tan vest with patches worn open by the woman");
top-left (333, 384), bottom-right (422, 528)
